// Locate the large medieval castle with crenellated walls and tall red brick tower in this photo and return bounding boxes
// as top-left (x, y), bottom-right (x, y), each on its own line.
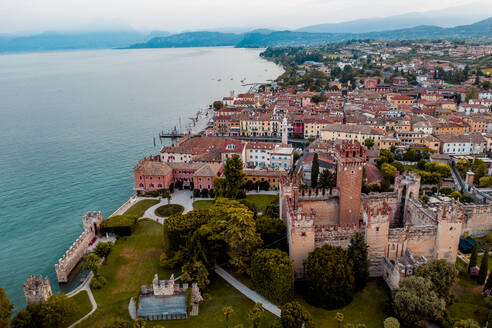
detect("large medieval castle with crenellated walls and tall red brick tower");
top-left (280, 141), bottom-right (492, 288)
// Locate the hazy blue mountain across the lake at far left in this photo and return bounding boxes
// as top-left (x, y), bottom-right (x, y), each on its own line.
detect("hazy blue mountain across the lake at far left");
top-left (0, 31), bottom-right (148, 52)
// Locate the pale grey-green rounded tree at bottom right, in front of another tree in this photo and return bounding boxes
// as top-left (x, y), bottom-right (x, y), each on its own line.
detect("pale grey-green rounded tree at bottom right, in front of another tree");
top-left (393, 276), bottom-right (446, 327)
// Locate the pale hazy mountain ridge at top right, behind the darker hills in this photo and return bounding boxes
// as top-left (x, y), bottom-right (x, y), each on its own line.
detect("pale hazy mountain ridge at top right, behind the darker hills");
top-left (296, 0), bottom-right (492, 33)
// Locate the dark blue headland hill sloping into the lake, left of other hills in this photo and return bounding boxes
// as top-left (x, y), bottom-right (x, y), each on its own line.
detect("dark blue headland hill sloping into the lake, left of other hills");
top-left (128, 32), bottom-right (243, 49)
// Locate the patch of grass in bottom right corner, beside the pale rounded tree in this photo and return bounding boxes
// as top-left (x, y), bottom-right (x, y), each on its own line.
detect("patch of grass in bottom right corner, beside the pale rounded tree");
top-left (446, 258), bottom-right (489, 325)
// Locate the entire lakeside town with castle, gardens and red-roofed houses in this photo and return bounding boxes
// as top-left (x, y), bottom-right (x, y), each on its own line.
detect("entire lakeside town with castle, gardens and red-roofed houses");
top-left (4, 40), bottom-right (492, 328)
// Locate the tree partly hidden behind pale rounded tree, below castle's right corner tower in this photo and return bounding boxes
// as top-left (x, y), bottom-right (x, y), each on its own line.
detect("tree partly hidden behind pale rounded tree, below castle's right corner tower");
top-left (415, 259), bottom-right (458, 303)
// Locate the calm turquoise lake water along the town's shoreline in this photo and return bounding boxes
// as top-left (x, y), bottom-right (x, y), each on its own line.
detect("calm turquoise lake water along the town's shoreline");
top-left (0, 48), bottom-right (282, 311)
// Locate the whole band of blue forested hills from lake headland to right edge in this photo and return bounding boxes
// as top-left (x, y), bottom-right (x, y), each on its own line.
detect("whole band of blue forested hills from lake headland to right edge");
top-left (129, 18), bottom-right (492, 48)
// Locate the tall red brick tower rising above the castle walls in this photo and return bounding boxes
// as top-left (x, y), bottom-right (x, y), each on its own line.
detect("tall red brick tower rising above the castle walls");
top-left (336, 140), bottom-right (366, 224)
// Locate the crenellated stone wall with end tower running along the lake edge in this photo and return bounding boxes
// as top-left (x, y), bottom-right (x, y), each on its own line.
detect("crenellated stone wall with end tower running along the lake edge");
top-left (55, 211), bottom-right (102, 283)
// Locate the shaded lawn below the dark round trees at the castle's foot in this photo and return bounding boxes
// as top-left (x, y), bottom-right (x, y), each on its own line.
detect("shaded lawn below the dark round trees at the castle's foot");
top-left (296, 279), bottom-right (391, 328)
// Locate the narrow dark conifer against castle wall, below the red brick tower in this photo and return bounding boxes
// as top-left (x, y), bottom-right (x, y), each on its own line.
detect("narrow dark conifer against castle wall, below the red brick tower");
top-left (347, 232), bottom-right (369, 290)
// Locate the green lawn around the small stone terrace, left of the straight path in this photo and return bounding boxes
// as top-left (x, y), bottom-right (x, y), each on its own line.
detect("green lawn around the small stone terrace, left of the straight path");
top-left (79, 220), bottom-right (274, 328)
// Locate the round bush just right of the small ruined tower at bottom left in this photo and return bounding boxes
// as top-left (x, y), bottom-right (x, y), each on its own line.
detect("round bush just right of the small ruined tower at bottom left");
top-left (45, 294), bottom-right (78, 328)
